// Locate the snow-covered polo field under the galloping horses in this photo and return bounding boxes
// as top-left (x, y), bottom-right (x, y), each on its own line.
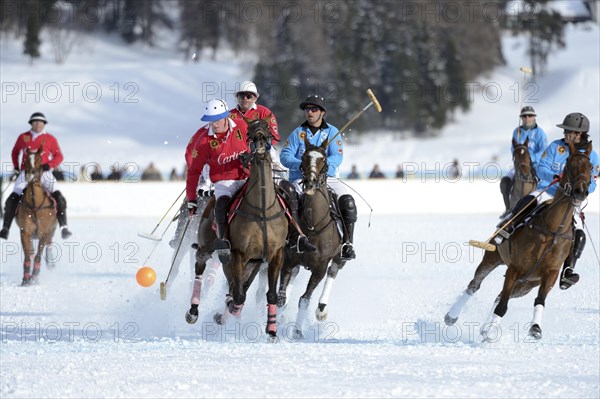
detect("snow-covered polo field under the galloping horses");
top-left (0, 180), bottom-right (600, 398)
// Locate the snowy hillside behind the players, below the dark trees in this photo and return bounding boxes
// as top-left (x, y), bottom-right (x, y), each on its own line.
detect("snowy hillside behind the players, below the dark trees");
top-left (0, 25), bottom-right (600, 175)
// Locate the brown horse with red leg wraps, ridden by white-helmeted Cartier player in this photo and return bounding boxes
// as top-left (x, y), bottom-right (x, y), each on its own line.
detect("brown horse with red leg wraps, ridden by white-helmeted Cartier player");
top-left (214, 119), bottom-right (288, 340)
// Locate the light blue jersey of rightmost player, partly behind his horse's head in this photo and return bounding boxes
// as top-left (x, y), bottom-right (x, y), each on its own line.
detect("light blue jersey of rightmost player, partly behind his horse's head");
top-left (538, 139), bottom-right (600, 196)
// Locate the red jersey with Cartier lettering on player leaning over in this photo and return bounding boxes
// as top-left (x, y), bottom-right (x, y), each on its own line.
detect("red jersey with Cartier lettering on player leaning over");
top-left (186, 120), bottom-right (250, 201)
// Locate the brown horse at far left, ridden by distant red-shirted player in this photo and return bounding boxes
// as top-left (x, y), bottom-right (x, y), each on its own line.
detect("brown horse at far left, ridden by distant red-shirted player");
top-left (16, 147), bottom-right (57, 286)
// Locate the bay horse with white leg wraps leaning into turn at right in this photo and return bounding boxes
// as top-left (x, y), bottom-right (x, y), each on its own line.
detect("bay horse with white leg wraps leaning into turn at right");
top-left (444, 142), bottom-right (592, 341)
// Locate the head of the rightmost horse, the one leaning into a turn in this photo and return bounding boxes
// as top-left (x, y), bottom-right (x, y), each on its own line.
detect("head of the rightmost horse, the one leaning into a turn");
top-left (560, 141), bottom-right (592, 206)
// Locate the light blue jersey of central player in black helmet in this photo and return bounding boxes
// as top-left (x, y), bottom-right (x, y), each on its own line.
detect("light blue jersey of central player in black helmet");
top-left (279, 122), bottom-right (344, 182)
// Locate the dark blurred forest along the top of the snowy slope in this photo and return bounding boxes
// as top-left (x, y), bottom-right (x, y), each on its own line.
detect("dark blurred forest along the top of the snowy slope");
top-left (0, 0), bottom-right (564, 135)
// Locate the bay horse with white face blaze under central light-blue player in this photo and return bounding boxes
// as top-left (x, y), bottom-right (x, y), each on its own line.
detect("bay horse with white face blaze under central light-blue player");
top-left (277, 138), bottom-right (346, 339)
